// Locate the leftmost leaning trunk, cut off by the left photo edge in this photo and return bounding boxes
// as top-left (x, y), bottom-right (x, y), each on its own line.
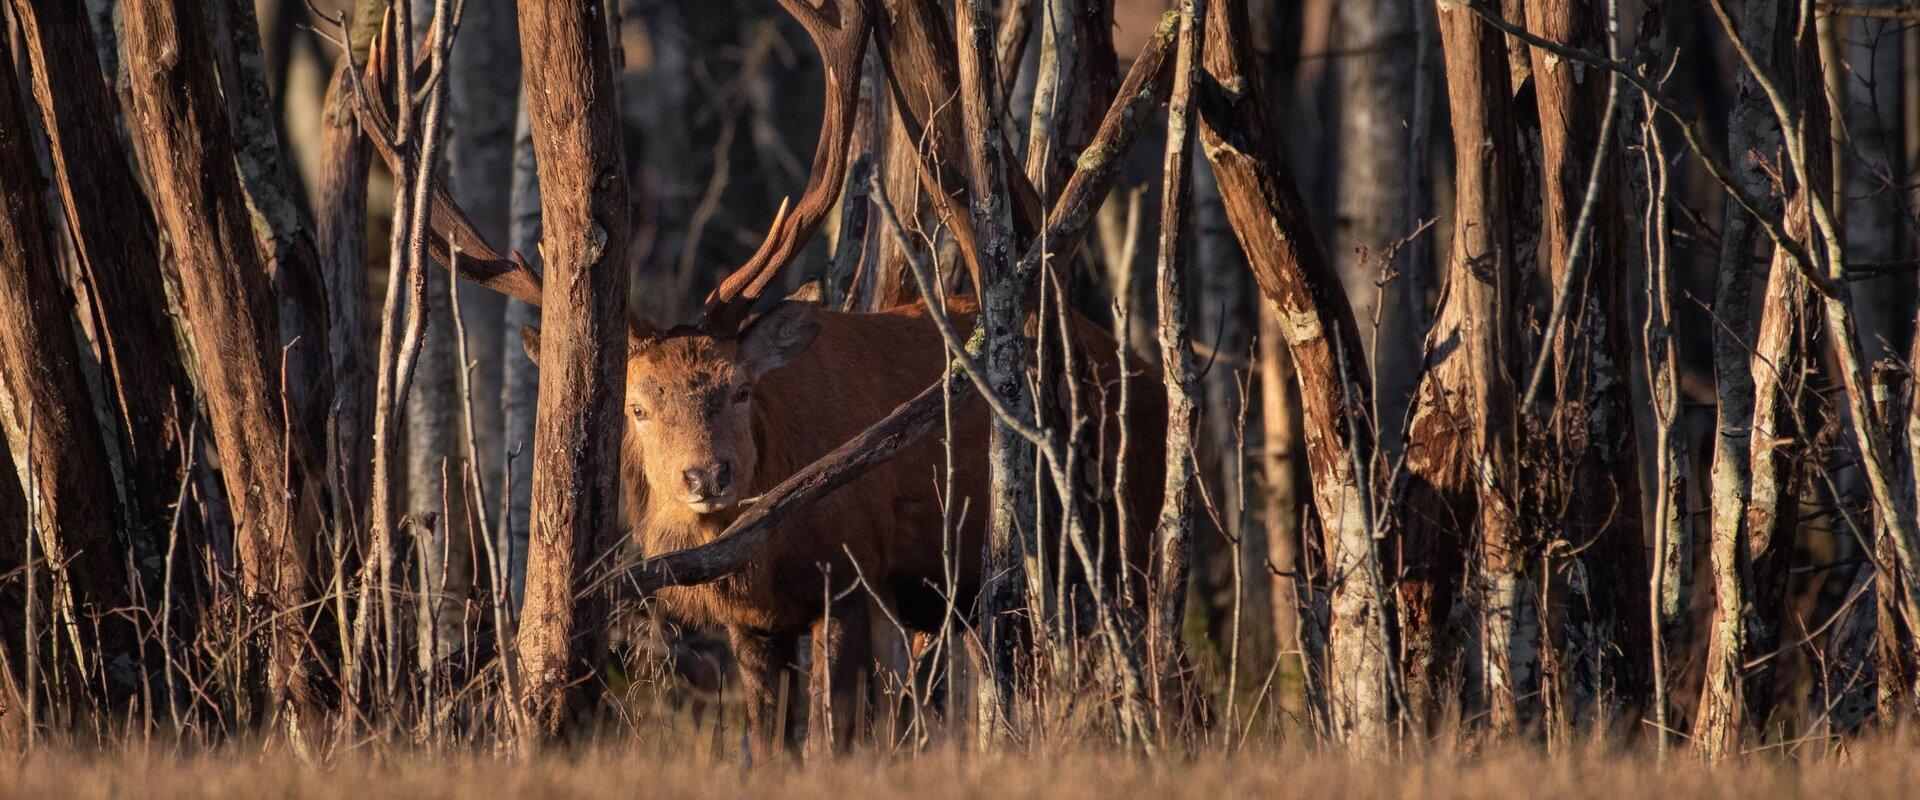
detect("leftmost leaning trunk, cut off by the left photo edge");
top-left (0, 52), bottom-right (140, 710)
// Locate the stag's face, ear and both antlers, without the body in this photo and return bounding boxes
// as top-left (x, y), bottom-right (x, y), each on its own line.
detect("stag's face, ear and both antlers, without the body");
top-left (355, 0), bottom-right (870, 514)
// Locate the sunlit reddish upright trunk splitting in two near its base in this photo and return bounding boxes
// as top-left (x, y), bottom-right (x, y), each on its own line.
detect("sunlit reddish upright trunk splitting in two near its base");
top-left (1404, 0), bottom-right (1534, 729)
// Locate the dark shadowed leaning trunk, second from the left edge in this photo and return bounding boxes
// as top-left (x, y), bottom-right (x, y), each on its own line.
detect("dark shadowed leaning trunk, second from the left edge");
top-left (12, 0), bottom-right (200, 577)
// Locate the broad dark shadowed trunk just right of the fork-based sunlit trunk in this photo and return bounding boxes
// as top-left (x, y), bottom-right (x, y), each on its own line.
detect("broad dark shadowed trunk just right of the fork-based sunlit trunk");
top-left (1526, 0), bottom-right (1649, 721)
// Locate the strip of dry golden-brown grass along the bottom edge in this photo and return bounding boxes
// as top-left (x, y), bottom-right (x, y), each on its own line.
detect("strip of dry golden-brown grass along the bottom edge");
top-left (0, 741), bottom-right (1920, 800)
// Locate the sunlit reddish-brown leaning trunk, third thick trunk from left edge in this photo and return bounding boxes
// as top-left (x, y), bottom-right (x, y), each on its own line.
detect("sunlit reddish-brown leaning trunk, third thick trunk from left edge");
top-left (125, 0), bottom-right (321, 714)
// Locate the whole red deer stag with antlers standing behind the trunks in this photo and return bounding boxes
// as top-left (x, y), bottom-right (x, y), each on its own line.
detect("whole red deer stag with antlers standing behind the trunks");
top-left (347, 0), bottom-right (1165, 748)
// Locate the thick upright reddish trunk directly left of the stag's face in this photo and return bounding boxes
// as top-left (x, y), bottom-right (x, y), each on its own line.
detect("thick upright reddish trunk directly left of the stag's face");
top-left (518, 0), bottom-right (628, 737)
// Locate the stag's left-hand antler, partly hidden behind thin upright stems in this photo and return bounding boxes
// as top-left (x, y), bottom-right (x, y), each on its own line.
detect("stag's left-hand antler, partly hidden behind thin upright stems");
top-left (346, 13), bottom-right (659, 341)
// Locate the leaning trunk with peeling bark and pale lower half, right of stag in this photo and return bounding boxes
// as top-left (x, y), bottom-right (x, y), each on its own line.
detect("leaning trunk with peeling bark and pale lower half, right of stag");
top-left (1200, 2), bottom-right (1398, 750)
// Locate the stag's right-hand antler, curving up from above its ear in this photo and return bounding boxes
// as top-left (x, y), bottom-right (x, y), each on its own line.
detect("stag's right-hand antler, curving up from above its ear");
top-left (701, 0), bottom-right (872, 334)
